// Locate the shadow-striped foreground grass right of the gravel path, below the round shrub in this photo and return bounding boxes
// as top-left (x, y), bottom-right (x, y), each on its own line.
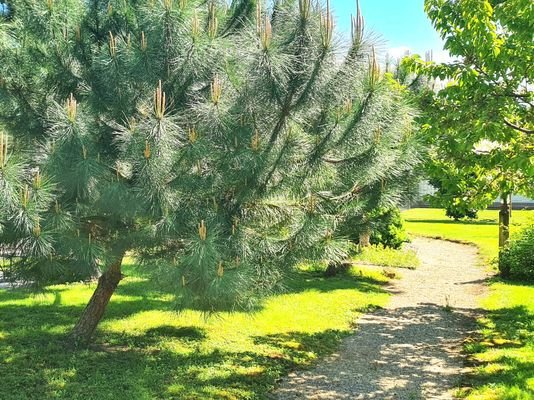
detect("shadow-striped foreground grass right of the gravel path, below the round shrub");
top-left (465, 281), bottom-right (534, 400)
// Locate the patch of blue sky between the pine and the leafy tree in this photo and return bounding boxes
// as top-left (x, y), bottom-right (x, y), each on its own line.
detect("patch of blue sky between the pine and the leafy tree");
top-left (330, 0), bottom-right (447, 61)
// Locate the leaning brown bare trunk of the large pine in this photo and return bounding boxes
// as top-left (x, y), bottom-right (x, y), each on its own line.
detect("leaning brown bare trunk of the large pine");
top-left (68, 253), bottom-right (124, 347)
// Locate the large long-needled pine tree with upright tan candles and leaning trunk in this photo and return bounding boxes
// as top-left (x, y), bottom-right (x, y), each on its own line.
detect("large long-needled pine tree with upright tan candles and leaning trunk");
top-left (0, 0), bottom-right (418, 344)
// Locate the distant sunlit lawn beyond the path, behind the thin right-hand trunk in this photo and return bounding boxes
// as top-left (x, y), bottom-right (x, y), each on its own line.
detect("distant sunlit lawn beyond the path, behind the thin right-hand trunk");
top-left (402, 208), bottom-right (534, 261)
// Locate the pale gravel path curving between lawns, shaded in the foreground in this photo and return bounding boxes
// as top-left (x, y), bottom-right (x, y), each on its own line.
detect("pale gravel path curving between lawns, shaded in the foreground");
top-left (273, 238), bottom-right (487, 400)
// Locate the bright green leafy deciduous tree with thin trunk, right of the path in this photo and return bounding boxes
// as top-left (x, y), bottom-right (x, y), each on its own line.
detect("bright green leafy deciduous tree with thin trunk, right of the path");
top-left (404, 0), bottom-right (534, 260)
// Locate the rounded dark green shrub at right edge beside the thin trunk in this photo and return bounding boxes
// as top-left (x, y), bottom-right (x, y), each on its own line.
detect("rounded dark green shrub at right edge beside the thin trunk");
top-left (499, 224), bottom-right (534, 281)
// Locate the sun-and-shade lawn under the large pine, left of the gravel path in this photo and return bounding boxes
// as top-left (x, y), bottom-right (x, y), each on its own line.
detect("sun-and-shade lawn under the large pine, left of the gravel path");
top-left (0, 262), bottom-right (388, 400)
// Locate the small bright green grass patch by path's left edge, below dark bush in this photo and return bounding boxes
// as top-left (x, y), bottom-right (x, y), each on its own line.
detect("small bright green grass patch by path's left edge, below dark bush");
top-left (354, 246), bottom-right (420, 269)
